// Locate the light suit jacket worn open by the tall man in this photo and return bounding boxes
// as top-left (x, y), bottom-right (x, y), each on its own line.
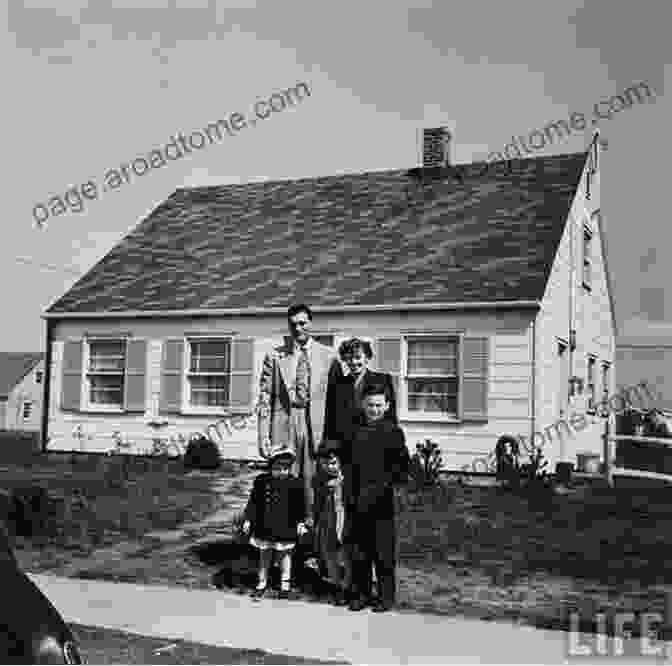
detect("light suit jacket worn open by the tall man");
top-left (258, 339), bottom-right (341, 458)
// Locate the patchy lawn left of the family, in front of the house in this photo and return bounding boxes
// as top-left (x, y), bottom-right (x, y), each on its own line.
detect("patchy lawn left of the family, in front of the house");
top-left (0, 454), bottom-right (255, 580)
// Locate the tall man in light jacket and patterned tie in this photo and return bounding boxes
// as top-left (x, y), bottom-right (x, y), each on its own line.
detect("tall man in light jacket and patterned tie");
top-left (259, 304), bottom-right (340, 515)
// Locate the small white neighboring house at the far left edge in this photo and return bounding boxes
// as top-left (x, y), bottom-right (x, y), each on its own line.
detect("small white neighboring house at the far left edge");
top-left (0, 352), bottom-right (44, 432)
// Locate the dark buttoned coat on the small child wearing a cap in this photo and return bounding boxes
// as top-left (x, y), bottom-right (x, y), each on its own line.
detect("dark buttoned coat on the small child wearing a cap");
top-left (245, 472), bottom-right (306, 542)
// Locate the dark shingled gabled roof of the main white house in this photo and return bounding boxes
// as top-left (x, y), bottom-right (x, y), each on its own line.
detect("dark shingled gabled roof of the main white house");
top-left (47, 153), bottom-right (587, 314)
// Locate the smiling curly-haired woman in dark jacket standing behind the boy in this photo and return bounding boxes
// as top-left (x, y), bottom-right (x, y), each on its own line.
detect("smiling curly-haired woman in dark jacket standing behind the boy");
top-left (324, 337), bottom-right (397, 462)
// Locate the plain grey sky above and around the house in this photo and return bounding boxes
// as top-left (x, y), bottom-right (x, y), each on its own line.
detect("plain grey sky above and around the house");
top-left (0, 0), bottom-right (672, 352)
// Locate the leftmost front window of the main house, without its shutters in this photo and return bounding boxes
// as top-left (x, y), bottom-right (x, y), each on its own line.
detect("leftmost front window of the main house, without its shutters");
top-left (86, 340), bottom-right (126, 408)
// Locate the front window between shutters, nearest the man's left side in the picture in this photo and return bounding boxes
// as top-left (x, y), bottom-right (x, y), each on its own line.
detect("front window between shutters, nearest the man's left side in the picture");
top-left (187, 338), bottom-right (231, 407)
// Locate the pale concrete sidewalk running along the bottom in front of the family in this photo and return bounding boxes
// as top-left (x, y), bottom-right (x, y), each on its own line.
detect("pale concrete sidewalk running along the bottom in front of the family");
top-left (31, 574), bottom-right (568, 664)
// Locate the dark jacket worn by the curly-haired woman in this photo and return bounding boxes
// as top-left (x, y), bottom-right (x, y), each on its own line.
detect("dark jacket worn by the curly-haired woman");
top-left (324, 369), bottom-right (398, 454)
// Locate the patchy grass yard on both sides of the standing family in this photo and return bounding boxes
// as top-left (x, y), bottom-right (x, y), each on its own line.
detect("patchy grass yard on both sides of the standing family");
top-left (0, 454), bottom-right (672, 634)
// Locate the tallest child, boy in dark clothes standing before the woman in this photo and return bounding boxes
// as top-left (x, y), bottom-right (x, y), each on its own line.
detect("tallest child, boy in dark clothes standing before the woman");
top-left (346, 384), bottom-right (410, 612)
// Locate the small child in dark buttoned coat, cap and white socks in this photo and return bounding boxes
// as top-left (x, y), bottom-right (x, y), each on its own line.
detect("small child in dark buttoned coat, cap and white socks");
top-left (243, 449), bottom-right (307, 599)
